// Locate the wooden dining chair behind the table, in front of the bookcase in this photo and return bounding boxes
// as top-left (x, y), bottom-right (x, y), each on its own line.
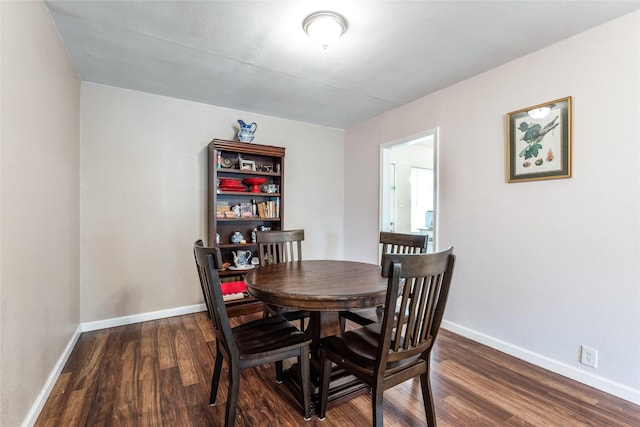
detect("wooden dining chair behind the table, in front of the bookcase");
top-left (256, 230), bottom-right (310, 328)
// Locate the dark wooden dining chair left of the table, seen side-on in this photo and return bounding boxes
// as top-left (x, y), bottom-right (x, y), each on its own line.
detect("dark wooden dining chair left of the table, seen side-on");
top-left (193, 240), bottom-right (311, 427)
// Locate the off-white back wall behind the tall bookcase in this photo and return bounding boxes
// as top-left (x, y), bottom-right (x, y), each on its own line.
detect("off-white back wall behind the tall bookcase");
top-left (80, 82), bottom-right (344, 322)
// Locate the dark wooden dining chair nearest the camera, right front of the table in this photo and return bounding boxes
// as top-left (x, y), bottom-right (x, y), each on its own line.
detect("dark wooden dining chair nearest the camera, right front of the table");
top-left (318, 248), bottom-right (455, 427)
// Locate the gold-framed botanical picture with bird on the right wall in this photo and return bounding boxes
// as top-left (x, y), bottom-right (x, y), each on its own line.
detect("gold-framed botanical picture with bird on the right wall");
top-left (507, 96), bottom-right (571, 182)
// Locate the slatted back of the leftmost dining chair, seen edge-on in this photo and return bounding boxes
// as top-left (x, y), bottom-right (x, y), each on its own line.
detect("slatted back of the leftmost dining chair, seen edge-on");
top-left (193, 240), bottom-right (238, 356)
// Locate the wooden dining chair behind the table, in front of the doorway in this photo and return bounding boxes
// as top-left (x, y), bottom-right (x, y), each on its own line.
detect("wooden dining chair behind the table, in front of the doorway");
top-left (340, 231), bottom-right (429, 331)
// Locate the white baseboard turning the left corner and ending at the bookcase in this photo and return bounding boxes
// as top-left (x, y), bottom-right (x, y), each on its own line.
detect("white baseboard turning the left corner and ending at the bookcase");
top-left (22, 304), bottom-right (207, 427)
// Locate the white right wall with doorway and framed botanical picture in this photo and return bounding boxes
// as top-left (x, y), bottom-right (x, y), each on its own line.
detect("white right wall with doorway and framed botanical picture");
top-left (345, 12), bottom-right (640, 403)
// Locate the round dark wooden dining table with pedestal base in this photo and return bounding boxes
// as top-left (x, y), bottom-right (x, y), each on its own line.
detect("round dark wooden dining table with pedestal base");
top-left (244, 260), bottom-right (387, 406)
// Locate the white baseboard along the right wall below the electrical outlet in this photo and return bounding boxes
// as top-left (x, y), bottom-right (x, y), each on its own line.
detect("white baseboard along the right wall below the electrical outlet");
top-left (442, 320), bottom-right (640, 405)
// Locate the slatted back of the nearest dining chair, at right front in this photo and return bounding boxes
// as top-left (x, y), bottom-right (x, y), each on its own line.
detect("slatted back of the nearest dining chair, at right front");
top-left (378, 248), bottom-right (455, 370)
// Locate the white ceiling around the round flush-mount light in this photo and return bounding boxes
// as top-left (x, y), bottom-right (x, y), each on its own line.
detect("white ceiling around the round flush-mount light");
top-left (46, 0), bottom-right (640, 129)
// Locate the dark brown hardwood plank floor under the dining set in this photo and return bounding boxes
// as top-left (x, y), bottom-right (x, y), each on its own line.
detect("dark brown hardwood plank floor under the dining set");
top-left (36, 312), bottom-right (640, 427)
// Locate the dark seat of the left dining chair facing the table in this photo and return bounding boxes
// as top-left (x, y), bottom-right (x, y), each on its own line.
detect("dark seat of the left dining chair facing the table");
top-left (232, 315), bottom-right (311, 359)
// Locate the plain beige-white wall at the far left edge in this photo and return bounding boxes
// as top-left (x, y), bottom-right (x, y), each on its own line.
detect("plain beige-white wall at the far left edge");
top-left (0, 1), bottom-right (80, 426)
